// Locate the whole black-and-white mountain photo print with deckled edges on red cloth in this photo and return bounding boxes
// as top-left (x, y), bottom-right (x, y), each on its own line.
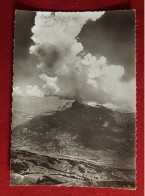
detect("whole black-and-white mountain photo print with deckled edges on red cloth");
top-left (10, 10), bottom-right (136, 189)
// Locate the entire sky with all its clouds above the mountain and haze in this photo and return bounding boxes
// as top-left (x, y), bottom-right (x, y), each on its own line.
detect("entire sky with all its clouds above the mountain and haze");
top-left (13, 11), bottom-right (136, 111)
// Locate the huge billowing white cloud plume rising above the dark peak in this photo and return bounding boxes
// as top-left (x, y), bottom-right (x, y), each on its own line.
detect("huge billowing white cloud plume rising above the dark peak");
top-left (30, 12), bottom-right (135, 110)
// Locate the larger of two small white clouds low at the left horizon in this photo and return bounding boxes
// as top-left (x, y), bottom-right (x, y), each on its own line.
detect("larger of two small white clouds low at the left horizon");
top-left (25, 85), bottom-right (44, 97)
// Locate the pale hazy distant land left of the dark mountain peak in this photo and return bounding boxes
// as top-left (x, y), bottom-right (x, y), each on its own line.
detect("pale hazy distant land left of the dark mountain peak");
top-left (11, 95), bottom-right (72, 129)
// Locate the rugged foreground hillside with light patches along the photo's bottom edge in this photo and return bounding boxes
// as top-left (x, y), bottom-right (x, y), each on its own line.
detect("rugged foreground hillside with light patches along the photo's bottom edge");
top-left (11, 151), bottom-right (135, 188)
